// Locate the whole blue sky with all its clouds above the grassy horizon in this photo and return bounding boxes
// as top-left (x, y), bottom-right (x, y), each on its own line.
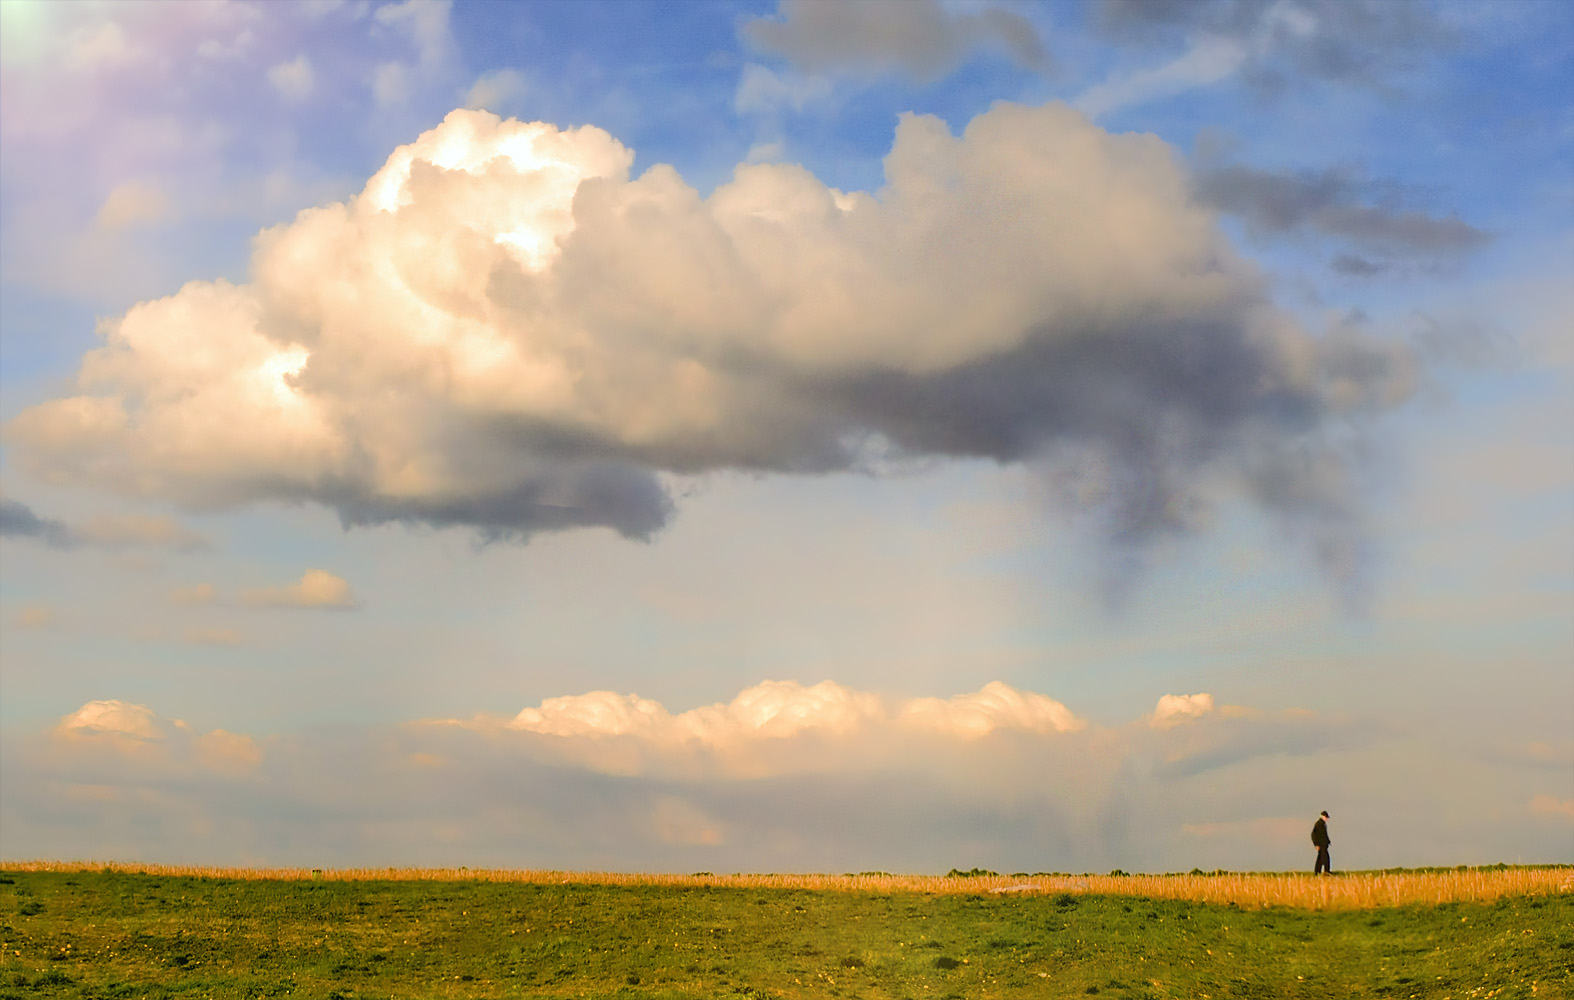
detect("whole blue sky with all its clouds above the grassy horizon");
top-left (0, 0), bottom-right (1574, 872)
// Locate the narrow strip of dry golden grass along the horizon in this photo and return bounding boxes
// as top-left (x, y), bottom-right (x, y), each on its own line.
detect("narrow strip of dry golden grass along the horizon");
top-left (5, 861), bottom-right (1574, 910)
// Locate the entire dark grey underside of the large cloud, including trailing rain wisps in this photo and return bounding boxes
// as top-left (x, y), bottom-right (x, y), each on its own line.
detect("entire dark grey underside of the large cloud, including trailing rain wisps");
top-left (315, 304), bottom-right (1406, 611)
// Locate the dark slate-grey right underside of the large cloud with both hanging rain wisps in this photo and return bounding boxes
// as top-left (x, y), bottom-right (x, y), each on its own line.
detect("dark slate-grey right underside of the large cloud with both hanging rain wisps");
top-left (822, 317), bottom-right (1407, 605)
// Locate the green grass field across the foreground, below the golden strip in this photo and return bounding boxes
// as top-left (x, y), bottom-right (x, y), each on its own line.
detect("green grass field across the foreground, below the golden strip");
top-left (0, 869), bottom-right (1574, 1000)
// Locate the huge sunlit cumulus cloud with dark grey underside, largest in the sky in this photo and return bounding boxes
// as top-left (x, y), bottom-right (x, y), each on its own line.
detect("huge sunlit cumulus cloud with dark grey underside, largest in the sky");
top-left (8, 104), bottom-right (1406, 570)
